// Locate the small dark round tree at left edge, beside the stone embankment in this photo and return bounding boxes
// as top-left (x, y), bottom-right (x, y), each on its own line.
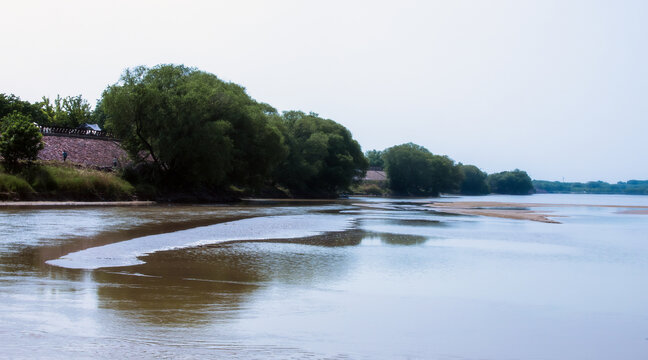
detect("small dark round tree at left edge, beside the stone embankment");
top-left (0, 112), bottom-right (43, 168)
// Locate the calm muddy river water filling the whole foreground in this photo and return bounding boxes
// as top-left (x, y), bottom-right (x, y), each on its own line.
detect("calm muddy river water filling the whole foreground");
top-left (0, 195), bottom-right (648, 359)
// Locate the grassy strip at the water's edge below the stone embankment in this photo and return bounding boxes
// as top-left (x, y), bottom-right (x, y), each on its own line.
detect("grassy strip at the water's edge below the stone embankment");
top-left (0, 163), bottom-right (135, 201)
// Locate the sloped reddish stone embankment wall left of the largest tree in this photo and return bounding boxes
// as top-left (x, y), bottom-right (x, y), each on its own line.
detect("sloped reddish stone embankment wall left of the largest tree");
top-left (38, 135), bottom-right (128, 168)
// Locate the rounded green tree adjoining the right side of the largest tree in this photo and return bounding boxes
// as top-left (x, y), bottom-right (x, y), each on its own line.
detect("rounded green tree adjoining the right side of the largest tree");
top-left (274, 111), bottom-right (368, 196)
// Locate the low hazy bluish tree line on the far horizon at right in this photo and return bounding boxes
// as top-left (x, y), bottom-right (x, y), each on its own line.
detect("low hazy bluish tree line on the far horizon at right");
top-left (533, 180), bottom-right (648, 195)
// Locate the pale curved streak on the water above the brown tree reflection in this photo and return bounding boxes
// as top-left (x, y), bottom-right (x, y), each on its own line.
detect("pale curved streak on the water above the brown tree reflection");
top-left (47, 214), bottom-right (354, 269)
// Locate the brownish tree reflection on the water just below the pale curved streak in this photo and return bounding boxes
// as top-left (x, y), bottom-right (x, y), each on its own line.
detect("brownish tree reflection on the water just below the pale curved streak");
top-left (93, 231), bottom-right (364, 325)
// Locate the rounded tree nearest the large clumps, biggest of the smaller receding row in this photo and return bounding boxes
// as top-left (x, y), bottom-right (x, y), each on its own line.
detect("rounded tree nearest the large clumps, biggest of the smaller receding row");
top-left (383, 143), bottom-right (462, 196)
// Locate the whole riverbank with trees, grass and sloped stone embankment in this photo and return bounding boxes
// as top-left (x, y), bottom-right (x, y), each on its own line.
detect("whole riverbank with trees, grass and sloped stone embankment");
top-left (0, 65), bottom-right (648, 201)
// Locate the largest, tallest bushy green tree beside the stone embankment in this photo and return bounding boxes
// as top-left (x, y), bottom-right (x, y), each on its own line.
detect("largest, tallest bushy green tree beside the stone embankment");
top-left (101, 65), bottom-right (286, 188)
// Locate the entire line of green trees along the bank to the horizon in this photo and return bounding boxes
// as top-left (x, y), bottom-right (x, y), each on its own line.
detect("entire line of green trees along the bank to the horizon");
top-left (12, 65), bottom-right (648, 197)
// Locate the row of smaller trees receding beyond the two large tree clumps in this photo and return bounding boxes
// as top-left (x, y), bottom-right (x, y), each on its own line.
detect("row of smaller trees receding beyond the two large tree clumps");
top-left (366, 143), bottom-right (534, 196)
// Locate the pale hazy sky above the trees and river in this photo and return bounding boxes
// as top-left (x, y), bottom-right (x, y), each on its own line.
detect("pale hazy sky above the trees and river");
top-left (0, 0), bottom-right (648, 182)
